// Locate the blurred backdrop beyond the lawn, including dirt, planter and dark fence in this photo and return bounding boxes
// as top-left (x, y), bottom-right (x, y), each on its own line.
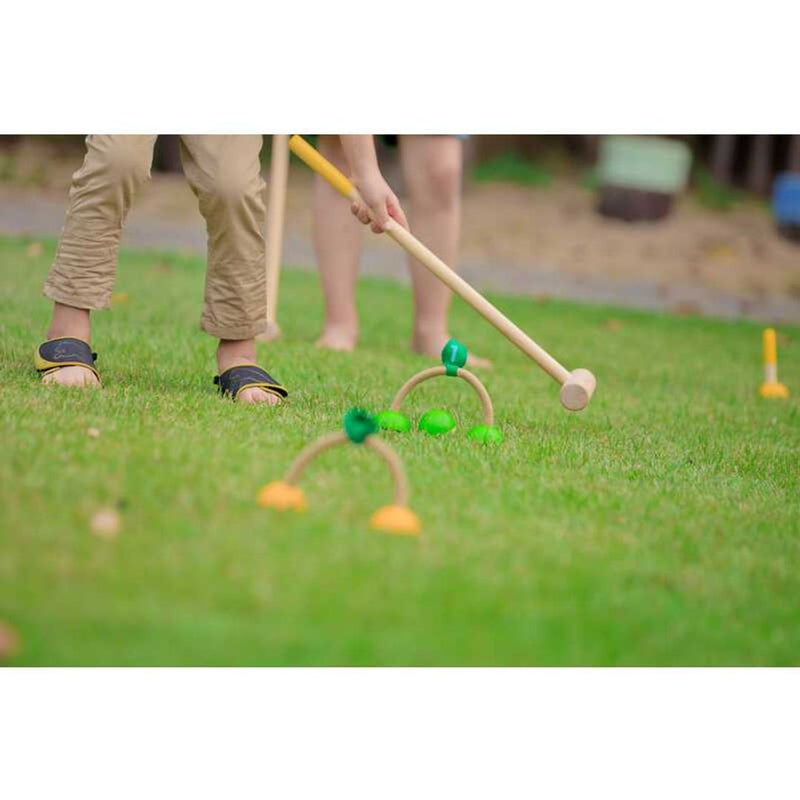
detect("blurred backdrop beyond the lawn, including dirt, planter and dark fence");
top-left (0, 135), bottom-right (800, 323)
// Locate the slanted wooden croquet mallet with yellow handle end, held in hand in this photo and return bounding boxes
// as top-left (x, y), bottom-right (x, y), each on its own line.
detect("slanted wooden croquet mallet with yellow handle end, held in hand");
top-left (289, 135), bottom-right (597, 411)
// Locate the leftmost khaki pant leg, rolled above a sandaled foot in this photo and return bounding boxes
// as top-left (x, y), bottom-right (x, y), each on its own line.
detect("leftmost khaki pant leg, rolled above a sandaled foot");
top-left (44, 135), bottom-right (156, 309)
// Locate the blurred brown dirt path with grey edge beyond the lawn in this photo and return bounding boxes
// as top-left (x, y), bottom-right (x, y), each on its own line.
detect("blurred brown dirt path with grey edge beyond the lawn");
top-left (0, 167), bottom-right (800, 323)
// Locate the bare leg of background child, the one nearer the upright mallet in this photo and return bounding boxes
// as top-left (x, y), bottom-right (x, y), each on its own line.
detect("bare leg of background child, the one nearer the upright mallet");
top-left (314, 136), bottom-right (362, 350)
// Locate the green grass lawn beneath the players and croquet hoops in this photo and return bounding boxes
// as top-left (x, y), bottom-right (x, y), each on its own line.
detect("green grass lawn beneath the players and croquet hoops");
top-left (0, 234), bottom-right (800, 665)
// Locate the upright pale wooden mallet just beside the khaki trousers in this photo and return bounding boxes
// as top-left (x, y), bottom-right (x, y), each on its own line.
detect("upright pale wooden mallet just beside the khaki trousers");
top-left (259, 133), bottom-right (289, 342)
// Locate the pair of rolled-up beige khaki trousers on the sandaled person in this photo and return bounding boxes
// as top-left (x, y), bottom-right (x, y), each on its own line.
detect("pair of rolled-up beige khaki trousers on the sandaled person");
top-left (44, 135), bottom-right (266, 339)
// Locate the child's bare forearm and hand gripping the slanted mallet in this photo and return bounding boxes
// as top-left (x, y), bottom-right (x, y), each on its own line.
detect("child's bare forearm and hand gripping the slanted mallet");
top-left (340, 134), bottom-right (408, 233)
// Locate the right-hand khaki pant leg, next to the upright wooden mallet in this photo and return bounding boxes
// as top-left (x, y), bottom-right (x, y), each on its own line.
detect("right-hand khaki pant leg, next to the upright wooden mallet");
top-left (181, 136), bottom-right (267, 339)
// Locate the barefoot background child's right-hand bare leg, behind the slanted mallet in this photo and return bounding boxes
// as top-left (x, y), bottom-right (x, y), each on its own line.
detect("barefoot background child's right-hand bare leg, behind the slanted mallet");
top-left (400, 136), bottom-right (489, 367)
